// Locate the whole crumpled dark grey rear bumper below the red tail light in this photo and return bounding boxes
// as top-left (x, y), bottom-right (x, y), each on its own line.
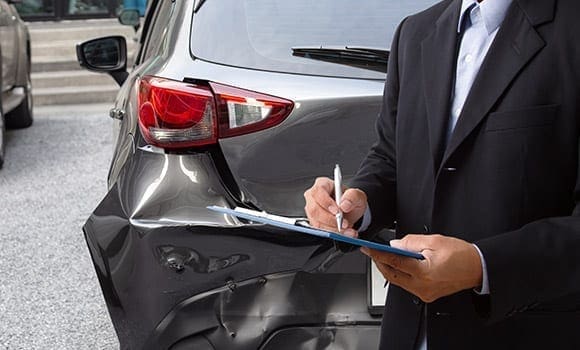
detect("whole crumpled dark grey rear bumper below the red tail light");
top-left (83, 150), bottom-right (380, 349)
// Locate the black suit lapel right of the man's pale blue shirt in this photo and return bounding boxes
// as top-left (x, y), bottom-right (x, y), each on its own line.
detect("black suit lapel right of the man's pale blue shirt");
top-left (441, 0), bottom-right (554, 165)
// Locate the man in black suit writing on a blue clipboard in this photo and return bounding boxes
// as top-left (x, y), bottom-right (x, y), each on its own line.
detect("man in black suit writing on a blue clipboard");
top-left (305, 0), bottom-right (580, 350)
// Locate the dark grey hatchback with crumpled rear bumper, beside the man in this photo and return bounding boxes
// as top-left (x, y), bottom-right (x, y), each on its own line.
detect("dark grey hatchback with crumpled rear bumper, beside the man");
top-left (77, 0), bottom-right (433, 350)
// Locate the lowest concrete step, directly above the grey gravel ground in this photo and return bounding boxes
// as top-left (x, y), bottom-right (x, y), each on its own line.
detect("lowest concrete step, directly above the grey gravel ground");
top-left (32, 85), bottom-right (119, 106)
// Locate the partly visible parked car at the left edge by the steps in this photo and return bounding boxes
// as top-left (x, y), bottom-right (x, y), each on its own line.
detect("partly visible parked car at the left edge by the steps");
top-left (0, 0), bottom-right (33, 168)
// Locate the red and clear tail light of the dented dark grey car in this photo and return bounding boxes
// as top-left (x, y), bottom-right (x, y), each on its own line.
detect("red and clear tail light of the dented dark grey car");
top-left (139, 76), bottom-right (293, 149)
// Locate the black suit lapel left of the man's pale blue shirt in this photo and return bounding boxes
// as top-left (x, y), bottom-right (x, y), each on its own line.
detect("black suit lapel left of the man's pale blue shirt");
top-left (421, 1), bottom-right (461, 171)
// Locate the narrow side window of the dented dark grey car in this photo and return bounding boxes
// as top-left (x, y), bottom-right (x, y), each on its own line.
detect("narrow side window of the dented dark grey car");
top-left (140, 1), bottom-right (175, 62)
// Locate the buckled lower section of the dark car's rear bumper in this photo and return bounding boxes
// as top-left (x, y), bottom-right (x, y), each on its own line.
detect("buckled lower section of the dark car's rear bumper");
top-left (145, 271), bottom-right (380, 350)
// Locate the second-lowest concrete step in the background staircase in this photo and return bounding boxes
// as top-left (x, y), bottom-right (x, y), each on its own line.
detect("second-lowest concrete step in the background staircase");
top-left (31, 69), bottom-right (117, 89)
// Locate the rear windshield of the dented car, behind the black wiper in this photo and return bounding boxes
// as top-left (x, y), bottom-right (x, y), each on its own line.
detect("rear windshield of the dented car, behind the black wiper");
top-left (191, 0), bottom-right (436, 79)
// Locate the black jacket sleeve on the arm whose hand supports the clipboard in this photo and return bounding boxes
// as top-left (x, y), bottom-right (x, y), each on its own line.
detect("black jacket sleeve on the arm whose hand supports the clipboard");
top-left (476, 194), bottom-right (580, 322)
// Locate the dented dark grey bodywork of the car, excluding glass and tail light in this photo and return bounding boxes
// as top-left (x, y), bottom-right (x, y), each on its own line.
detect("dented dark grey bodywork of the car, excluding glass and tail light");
top-left (83, 0), bottom-right (436, 349)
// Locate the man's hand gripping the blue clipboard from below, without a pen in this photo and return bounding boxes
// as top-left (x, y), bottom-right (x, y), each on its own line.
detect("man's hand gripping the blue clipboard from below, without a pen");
top-left (361, 235), bottom-right (483, 303)
